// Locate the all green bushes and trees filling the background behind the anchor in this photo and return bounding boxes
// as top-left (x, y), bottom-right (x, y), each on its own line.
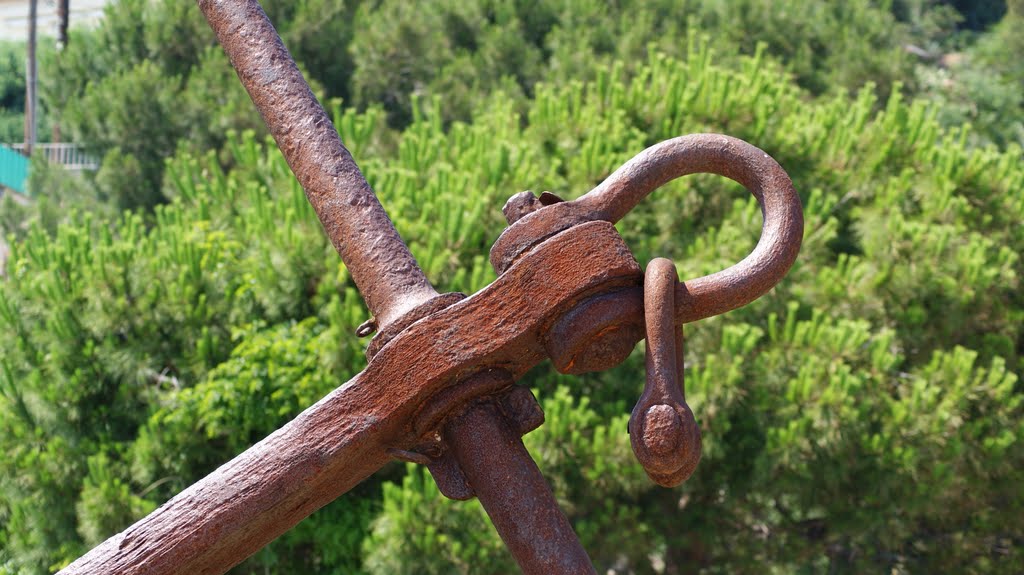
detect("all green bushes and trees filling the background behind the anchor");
top-left (0, 0), bottom-right (1024, 574)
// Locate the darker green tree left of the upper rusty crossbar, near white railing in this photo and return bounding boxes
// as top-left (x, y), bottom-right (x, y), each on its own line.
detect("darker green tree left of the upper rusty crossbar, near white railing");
top-left (33, 0), bottom-right (261, 210)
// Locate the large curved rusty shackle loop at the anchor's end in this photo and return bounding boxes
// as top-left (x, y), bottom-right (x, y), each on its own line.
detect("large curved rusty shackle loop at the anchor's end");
top-left (490, 134), bottom-right (804, 323)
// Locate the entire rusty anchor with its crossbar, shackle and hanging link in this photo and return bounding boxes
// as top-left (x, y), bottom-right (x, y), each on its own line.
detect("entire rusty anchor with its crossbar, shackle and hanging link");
top-left (61, 0), bottom-right (803, 574)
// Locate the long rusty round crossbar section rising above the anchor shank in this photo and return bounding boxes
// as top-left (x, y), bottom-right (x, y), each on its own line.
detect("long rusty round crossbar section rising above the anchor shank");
top-left (198, 0), bottom-right (437, 327)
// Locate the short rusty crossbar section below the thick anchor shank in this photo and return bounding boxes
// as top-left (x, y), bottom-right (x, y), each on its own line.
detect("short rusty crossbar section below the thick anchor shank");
top-left (444, 403), bottom-right (597, 575)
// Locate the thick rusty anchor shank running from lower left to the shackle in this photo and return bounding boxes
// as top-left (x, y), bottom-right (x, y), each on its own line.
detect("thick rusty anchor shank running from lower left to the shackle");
top-left (61, 222), bottom-right (641, 575)
